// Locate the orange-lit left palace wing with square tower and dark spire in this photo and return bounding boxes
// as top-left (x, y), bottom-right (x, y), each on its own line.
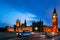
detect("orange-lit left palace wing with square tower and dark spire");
top-left (7, 19), bottom-right (32, 32)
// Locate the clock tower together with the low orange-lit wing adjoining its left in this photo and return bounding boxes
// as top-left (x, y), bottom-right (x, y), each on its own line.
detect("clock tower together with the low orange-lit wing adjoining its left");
top-left (43, 9), bottom-right (58, 32)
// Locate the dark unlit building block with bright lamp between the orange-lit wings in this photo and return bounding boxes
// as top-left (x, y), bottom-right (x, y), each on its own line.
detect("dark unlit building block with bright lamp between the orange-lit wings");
top-left (32, 20), bottom-right (43, 32)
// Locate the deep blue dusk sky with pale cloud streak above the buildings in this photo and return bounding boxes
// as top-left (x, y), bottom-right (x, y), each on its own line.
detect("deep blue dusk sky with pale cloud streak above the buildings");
top-left (0, 0), bottom-right (60, 27)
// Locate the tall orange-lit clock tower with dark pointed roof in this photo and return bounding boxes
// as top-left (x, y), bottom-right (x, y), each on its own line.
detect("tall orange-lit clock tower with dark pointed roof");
top-left (52, 8), bottom-right (58, 32)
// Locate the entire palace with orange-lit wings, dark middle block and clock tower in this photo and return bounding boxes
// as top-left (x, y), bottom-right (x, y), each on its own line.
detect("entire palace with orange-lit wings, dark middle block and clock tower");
top-left (7, 8), bottom-right (58, 32)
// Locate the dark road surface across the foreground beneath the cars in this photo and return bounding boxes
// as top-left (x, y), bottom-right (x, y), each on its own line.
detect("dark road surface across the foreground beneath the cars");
top-left (0, 32), bottom-right (60, 40)
